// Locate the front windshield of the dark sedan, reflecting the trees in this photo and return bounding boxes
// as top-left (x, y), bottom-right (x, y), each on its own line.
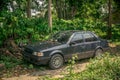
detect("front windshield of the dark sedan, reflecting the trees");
top-left (52, 31), bottom-right (72, 43)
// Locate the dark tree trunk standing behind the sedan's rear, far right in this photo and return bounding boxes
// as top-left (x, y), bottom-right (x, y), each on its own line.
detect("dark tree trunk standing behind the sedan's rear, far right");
top-left (107, 0), bottom-right (112, 39)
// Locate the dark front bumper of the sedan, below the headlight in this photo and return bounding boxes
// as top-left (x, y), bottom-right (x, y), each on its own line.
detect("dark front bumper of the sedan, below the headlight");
top-left (23, 52), bottom-right (49, 65)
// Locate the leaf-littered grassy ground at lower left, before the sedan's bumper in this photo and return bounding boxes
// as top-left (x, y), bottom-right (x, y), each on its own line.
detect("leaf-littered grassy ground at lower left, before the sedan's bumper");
top-left (0, 55), bottom-right (46, 77)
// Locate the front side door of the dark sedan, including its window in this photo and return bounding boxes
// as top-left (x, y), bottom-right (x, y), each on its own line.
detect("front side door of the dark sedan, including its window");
top-left (70, 33), bottom-right (85, 59)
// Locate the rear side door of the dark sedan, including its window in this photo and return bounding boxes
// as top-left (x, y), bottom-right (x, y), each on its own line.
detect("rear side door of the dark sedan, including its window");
top-left (83, 32), bottom-right (100, 58)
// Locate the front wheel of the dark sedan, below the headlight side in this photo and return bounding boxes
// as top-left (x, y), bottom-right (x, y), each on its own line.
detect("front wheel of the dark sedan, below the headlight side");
top-left (49, 54), bottom-right (64, 69)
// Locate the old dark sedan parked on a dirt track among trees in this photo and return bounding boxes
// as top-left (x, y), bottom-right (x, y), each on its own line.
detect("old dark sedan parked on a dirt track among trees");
top-left (23, 31), bottom-right (108, 69)
